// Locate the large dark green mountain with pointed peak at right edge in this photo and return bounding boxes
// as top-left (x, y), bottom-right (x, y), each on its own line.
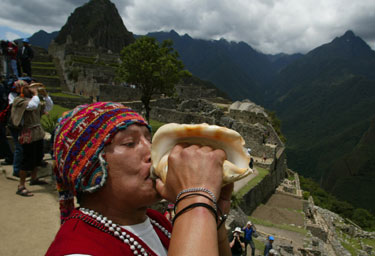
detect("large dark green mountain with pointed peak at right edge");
top-left (267, 31), bottom-right (375, 209)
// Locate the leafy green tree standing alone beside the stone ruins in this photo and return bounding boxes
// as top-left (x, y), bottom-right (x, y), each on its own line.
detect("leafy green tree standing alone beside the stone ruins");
top-left (117, 36), bottom-right (191, 121)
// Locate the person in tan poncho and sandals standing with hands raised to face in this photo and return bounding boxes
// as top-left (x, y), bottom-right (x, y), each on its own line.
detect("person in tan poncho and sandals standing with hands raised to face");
top-left (11, 83), bottom-right (53, 196)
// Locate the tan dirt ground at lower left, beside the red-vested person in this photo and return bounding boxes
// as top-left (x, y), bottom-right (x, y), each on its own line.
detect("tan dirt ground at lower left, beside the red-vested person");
top-left (0, 160), bottom-right (60, 256)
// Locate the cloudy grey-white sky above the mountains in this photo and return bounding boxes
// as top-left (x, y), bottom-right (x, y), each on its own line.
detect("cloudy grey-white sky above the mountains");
top-left (0, 0), bottom-right (375, 53)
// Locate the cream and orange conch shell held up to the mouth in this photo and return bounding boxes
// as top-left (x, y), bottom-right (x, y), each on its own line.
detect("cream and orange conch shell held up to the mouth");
top-left (151, 123), bottom-right (253, 186)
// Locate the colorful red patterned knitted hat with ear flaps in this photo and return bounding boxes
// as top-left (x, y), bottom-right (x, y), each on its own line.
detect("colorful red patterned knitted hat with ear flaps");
top-left (53, 102), bottom-right (151, 222)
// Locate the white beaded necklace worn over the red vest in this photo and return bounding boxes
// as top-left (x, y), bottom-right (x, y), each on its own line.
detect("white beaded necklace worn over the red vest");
top-left (67, 208), bottom-right (171, 256)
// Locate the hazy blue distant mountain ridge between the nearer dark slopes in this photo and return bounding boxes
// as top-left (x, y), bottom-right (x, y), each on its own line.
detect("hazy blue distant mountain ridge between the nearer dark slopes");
top-left (147, 30), bottom-right (299, 104)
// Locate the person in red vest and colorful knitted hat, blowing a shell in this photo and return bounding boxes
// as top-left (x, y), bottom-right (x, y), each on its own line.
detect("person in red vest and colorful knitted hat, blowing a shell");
top-left (46, 102), bottom-right (233, 256)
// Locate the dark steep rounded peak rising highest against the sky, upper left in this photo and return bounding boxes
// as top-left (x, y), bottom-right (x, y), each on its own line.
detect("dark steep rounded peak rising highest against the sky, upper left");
top-left (55, 0), bottom-right (134, 52)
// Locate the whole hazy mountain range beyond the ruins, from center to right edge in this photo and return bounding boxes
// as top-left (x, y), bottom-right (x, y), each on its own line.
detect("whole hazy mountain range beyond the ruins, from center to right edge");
top-left (30, 26), bottom-right (375, 210)
